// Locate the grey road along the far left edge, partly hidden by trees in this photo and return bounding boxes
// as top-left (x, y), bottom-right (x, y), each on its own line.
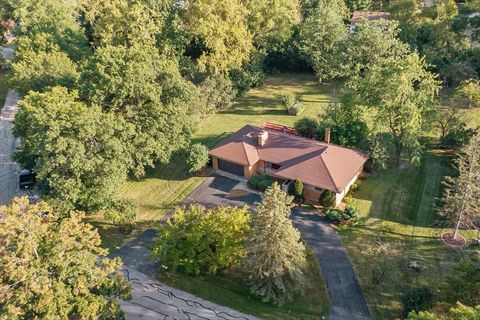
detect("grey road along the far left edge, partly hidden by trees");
top-left (0, 43), bottom-right (19, 205)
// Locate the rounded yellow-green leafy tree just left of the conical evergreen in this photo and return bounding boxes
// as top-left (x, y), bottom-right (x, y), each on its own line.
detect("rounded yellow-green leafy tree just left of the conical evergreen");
top-left (152, 205), bottom-right (249, 275)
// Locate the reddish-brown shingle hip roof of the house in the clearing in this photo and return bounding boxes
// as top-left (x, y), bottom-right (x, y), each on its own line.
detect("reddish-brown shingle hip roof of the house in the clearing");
top-left (209, 125), bottom-right (367, 192)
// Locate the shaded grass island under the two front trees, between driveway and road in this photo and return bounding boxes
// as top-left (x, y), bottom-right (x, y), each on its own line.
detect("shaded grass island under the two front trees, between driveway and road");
top-left (160, 248), bottom-right (329, 320)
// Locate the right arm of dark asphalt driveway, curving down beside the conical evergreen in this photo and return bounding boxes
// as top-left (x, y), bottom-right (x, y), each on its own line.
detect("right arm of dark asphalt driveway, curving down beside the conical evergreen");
top-left (291, 208), bottom-right (371, 320)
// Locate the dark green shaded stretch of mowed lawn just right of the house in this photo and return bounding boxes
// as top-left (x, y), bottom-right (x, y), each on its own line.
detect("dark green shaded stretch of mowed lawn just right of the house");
top-left (353, 152), bottom-right (451, 227)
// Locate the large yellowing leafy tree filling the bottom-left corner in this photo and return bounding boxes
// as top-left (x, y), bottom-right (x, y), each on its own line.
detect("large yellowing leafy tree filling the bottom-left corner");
top-left (0, 198), bottom-right (131, 319)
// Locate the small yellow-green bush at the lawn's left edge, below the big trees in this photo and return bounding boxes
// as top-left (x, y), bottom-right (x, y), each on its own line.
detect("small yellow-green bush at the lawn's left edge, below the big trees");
top-left (103, 200), bottom-right (138, 234)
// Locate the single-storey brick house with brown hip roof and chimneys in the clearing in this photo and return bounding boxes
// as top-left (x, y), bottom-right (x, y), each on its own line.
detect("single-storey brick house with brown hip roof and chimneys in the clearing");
top-left (209, 125), bottom-right (367, 205)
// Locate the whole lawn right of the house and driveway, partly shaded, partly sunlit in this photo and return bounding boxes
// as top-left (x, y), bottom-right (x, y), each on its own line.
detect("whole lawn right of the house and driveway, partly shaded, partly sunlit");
top-left (339, 150), bottom-right (472, 319)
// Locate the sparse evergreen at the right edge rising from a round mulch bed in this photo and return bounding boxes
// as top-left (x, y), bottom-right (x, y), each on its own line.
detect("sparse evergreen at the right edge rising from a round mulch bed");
top-left (440, 132), bottom-right (480, 239)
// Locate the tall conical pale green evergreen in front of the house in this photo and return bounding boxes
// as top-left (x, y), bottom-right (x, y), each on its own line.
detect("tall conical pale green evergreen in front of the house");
top-left (244, 183), bottom-right (306, 305)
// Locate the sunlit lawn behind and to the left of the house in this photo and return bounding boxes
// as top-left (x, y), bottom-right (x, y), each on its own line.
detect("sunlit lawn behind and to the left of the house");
top-left (92, 73), bottom-right (337, 248)
